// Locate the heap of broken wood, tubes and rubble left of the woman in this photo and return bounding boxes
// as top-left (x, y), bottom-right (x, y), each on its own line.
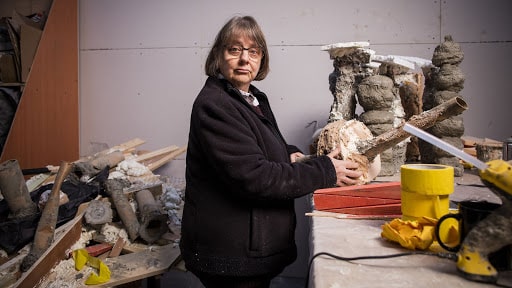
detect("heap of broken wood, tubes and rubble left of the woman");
top-left (0, 139), bottom-right (186, 287)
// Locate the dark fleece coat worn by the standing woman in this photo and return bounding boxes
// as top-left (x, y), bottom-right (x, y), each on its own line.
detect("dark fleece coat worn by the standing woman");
top-left (180, 77), bottom-right (336, 276)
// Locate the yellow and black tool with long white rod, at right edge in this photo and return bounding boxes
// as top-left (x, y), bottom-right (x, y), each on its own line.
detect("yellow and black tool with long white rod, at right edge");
top-left (403, 124), bottom-right (512, 283)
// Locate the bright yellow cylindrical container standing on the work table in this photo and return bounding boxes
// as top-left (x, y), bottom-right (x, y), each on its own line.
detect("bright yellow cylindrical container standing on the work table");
top-left (400, 164), bottom-right (454, 220)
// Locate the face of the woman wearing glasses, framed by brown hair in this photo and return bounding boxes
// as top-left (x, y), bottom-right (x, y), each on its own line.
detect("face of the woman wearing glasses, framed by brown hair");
top-left (219, 37), bottom-right (263, 92)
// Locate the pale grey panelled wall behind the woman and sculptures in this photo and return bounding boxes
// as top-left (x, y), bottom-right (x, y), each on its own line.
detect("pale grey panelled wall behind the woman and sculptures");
top-left (79, 0), bottom-right (512, 275)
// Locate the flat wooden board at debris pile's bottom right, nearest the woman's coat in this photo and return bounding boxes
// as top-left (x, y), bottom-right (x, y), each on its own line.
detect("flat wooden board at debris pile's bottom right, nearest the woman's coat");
top-left (87, 243), bottom-right (180, 287)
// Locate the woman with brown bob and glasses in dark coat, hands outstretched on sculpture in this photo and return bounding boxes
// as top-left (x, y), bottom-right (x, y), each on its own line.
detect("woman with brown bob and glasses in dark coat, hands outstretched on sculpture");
top-left (180, 16), bottom-right (361, 288)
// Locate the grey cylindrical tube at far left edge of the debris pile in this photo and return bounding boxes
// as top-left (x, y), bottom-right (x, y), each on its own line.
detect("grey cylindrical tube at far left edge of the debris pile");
top-left (0, 159), bottom-right (37, 219)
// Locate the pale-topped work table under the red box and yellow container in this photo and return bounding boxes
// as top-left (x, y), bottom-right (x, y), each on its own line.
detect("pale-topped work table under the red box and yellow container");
top-left (309, 174), bottom-right (512, 288)
